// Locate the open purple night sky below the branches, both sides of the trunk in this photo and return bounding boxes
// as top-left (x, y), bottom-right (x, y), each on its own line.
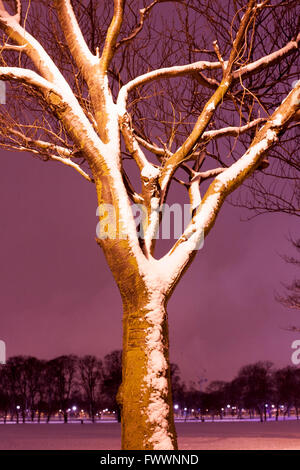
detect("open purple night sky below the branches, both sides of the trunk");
top-left (0, 151), bottom-right (300, 388)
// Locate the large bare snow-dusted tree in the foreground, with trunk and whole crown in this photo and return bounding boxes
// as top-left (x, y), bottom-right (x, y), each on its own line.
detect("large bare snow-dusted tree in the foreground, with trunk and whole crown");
top-left (0, 0), bottom-right (300, 449)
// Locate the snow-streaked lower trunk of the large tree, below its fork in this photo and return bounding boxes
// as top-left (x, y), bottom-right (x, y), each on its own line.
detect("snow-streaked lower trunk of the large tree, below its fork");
top-left (118, 293), bottom-right (177, 450)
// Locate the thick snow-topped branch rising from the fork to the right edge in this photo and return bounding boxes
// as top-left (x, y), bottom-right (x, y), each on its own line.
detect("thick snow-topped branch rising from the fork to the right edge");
top-left (161, 83), bottom-right (300, 289)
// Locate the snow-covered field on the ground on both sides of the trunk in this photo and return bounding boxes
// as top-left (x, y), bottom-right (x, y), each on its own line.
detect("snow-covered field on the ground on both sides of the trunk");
top-left (0, 421), bottom-right (300, 450)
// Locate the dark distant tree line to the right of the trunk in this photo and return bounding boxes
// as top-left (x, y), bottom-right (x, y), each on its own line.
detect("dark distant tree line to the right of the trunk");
top-left (173, 362), bottom-right (300, 421)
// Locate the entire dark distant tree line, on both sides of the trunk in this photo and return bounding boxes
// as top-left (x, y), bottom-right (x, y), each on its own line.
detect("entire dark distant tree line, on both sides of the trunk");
top-left (0, 356), bottom-right (300, 423)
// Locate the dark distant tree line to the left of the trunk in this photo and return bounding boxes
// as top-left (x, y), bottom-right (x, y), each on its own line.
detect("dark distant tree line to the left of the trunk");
top-left (0, 351), bottom-right (122, 423)
